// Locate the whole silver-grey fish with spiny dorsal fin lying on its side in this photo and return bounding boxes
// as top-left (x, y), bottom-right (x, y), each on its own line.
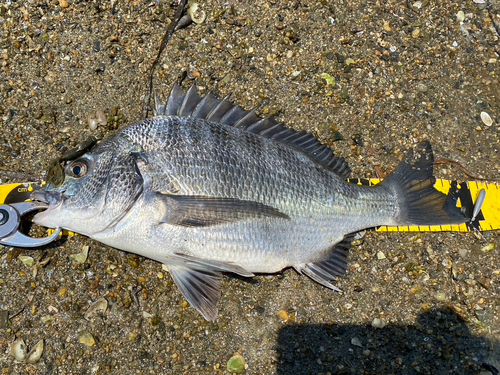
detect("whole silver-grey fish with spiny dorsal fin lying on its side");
top-left (33, 83), bottom-right (468, 321)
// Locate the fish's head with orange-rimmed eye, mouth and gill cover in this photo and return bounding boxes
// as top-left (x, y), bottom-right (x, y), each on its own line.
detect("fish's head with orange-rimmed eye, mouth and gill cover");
top-left (33, 142), bottom-right (143, 236)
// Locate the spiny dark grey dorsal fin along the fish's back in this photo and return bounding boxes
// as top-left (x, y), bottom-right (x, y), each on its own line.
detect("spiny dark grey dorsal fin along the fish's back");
top-left (154, 83), bottom-right (351, 179)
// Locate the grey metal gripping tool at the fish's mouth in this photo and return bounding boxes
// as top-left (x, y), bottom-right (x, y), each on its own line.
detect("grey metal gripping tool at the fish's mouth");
top-left (0, 202), bottom-right (61, 247)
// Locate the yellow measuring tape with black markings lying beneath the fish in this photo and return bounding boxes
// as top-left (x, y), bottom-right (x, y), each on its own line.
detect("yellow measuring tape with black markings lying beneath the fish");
top-left (0, 178), bottom-right (500, 235)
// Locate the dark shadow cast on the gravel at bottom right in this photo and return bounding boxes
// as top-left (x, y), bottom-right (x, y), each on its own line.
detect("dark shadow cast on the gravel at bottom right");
top-left (276, 309), bottom-right (500, 375)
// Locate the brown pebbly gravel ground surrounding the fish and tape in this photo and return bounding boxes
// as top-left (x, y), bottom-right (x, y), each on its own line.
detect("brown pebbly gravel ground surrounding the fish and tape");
top-left (0, 0), bottom-right (500, 375)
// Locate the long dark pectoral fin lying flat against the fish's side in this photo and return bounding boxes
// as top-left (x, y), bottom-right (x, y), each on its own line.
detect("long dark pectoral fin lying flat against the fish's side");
top-left (156, 194), bottom-right (290, 227)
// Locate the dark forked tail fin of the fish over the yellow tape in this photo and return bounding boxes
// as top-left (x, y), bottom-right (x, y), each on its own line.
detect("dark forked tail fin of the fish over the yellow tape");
top-left (381, 141), bottom-right (469, 225)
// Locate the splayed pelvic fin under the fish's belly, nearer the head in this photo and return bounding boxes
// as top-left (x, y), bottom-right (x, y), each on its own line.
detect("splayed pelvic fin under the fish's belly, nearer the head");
top-left (165, 254), bottom-right (253, 321)
